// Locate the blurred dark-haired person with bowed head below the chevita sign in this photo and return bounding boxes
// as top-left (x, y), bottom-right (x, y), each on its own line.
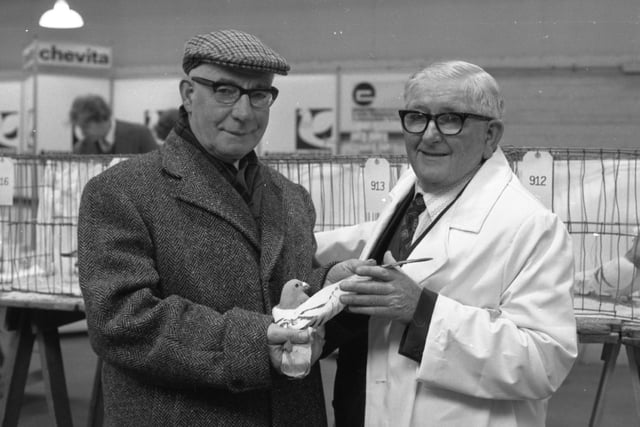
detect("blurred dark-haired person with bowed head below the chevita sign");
top-left (69, 95), bottom-right (158, 154)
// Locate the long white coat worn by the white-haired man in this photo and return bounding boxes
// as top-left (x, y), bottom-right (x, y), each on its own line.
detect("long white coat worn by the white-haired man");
top-left (318, 149), bottom-right (577, 427)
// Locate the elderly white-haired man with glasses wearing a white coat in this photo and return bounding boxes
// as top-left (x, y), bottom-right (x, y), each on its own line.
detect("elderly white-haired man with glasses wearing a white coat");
top-left (318, 61), bottom-right (577, 427)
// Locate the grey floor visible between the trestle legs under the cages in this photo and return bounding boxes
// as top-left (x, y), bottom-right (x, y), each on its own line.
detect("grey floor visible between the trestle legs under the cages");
top-left (6, 331), bottom-right (640, 427)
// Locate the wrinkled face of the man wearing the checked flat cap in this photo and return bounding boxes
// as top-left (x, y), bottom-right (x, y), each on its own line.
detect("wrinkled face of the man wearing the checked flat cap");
top-left (180, 64), bottom-right (273, 163)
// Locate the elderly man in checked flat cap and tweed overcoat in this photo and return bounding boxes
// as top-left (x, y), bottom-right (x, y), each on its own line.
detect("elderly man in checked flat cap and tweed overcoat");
top-left (78, 30), bottom-right (358, 426)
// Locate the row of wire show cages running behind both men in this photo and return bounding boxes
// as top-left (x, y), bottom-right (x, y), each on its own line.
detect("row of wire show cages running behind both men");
top-left (0, 147), bottom-right (640, 321)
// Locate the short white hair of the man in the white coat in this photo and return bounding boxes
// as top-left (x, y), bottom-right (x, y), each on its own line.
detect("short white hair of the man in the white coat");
top-left (404, 60), bottom-right (504, 119)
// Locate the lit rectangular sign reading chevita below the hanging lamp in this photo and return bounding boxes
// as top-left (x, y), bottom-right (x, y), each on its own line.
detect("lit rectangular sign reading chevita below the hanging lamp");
top-left (22, 41), bottom-right (113, 69)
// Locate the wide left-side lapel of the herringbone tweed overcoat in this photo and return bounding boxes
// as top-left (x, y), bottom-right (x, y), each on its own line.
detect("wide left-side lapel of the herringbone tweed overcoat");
top-left (161, 137), bottom-right (260, 250)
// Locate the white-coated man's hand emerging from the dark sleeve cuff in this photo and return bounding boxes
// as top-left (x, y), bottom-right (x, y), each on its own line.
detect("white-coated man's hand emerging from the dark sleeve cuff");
top-left (340, 254), bottom-right (422, 323)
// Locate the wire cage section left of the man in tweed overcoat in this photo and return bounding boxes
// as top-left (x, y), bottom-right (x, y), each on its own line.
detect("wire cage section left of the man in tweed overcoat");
top-left (0, 155), bottom-right (121, 296)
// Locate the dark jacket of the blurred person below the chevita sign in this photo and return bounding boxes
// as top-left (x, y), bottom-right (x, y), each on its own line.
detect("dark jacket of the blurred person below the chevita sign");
top-left (73, 120), bottom-right (158, 154)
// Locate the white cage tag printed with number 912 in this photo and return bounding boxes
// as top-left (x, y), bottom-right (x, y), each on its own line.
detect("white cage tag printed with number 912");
top-left (520, 151), bottom-right (553, 209)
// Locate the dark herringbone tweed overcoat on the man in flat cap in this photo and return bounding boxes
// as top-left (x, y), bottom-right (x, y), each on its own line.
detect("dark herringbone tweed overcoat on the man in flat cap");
top-left (78, 132), bottom-right (327, 426)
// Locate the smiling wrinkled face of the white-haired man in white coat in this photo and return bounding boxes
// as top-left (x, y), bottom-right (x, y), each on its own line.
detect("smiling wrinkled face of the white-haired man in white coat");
top-left (404, 81), bottom-right (502, 191)
